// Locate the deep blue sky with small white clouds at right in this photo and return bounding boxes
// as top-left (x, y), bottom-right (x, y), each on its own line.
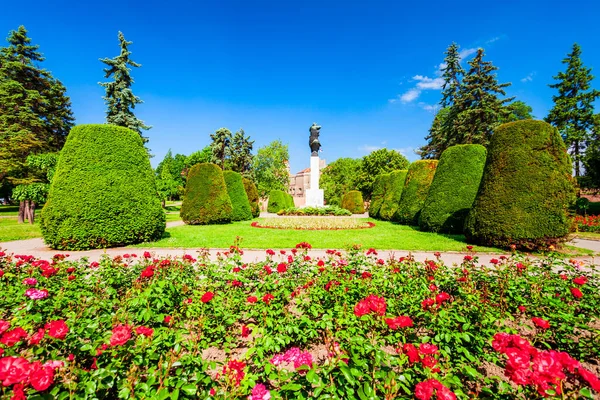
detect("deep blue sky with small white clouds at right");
top-left (0, 0), bottom-right (600, 171)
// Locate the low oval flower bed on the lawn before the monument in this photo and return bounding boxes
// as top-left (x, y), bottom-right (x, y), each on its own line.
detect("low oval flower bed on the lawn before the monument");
top-left (251, 217), bottom-right (375, 230)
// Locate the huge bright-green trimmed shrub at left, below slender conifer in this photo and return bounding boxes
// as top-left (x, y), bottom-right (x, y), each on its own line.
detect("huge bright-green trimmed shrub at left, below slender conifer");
top-left (40, 125), bottom-right (165, 250)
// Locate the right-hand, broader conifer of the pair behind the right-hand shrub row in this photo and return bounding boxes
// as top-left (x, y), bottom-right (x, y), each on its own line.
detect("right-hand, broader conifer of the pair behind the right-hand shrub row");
top-left (452, 49), bottom-right (513, 145)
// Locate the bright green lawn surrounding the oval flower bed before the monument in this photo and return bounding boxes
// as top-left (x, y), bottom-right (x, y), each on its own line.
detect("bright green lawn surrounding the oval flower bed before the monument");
top-left (137, 219), bottom-right (500, 252)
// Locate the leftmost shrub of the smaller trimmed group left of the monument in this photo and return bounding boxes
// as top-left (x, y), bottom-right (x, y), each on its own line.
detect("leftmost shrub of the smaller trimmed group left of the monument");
top-left (180, 163), bottom-right (233, 225)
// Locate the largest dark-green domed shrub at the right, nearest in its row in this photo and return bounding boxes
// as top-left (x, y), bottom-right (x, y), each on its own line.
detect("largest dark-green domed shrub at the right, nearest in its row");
top-left (465, 120), bottom-right (575, 249)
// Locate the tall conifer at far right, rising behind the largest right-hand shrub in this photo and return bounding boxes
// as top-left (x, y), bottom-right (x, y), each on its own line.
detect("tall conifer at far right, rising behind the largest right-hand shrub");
top-left (545, 43), bottom-right (600, 176)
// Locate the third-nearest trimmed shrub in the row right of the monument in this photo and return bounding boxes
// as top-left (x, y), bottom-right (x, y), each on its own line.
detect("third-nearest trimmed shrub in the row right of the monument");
top-left (392, 160), bottom-right (438, 225)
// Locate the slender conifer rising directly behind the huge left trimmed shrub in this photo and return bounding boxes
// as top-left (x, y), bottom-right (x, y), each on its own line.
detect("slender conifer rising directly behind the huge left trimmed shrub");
top-left (99, 32), bottom-right (150, 143)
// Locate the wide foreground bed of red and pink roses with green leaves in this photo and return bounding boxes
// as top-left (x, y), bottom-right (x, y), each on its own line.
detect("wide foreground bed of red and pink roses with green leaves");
top-left (0, 248), bottom-right (600, 400)
